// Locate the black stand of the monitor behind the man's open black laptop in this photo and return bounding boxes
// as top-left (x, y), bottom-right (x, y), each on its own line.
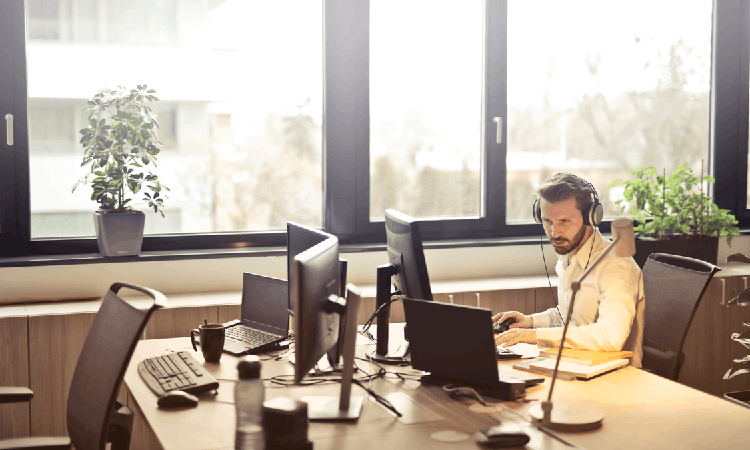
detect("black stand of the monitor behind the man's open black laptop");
top-left (368, 264), bottom-right (411, 366)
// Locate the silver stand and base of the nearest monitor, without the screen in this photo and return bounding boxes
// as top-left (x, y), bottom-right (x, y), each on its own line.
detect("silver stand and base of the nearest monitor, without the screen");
top-left (302, 284), bottom-right (364, 421)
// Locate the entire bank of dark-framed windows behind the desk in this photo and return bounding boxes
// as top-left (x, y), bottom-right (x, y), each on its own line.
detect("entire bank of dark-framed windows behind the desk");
top-left (0, 0), bottom-right (750, 254)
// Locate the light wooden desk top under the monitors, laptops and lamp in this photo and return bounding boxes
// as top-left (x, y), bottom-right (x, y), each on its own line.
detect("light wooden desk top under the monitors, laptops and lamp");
top-left (125, 324), bottom-right (750, 450)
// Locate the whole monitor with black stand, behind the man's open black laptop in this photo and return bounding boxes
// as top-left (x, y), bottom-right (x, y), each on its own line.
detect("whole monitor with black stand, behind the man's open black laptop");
top-left (372, 209), bottom-right (432, 364)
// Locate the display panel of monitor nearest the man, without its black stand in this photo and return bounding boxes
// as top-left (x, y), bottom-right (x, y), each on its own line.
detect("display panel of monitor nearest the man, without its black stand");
top-left (385, 209), bottom-right (432, 300)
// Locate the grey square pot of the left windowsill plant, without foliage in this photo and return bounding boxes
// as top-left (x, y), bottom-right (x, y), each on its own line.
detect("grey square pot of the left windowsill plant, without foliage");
top-left (94, 211), bottom-right (146, 256)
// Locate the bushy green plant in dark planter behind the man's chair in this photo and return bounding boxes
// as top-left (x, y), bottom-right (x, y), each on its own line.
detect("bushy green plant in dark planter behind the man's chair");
top-left (609, 164), bottom-right (739, 267)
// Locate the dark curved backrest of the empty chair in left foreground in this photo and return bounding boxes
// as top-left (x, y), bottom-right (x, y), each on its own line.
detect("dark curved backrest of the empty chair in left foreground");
top-left (67, 283), bottom-right (167, 450)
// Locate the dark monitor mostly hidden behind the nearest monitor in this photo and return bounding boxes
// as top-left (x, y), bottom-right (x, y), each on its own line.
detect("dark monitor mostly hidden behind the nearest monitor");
top-left (286, 222), bottom-right (347, 372)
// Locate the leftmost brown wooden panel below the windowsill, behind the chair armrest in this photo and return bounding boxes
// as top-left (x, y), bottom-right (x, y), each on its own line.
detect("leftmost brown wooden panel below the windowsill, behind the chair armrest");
top-left (0, 307), bottom-right (29, 439)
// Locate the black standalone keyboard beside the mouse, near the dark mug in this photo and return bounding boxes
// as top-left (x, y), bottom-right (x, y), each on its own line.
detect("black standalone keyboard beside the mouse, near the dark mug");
top-left (138, 351), bottom-right (219, 397)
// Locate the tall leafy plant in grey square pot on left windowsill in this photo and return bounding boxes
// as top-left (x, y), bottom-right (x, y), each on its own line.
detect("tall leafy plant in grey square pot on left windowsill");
top-left (73, 85), bottom-right (169, 256)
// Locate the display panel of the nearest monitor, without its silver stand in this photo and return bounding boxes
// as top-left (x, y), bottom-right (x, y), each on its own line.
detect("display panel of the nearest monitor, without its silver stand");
top-left (290, 236), bottom-right (341, 383)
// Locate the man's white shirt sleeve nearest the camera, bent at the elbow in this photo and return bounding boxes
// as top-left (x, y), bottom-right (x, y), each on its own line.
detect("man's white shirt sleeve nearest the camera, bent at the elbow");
top-left (536, 258), bottom-right (640, 351)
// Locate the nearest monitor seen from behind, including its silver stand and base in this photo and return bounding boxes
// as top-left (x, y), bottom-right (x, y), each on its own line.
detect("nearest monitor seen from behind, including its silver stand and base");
top-left (290, 236), bottom-right (362, 420)
